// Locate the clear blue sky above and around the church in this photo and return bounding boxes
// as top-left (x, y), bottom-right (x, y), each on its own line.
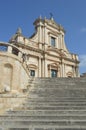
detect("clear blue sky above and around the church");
top-left (0, 0), bottom-right (86, 73)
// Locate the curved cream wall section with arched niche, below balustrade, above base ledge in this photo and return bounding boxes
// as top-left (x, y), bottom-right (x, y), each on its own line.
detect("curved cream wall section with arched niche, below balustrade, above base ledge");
top-left (0, 52), bottom-right (28, 92)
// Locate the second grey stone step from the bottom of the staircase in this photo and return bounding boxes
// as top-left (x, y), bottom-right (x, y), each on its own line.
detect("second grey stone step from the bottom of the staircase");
top-left (0, 115), bottom-right (86, 122)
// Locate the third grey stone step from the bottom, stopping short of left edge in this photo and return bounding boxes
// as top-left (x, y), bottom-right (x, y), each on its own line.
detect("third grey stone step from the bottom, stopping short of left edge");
top-left (6, 109), bottom-right (86, 116)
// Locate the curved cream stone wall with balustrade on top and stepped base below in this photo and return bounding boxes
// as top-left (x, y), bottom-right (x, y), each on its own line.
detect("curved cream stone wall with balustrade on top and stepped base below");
top-left (0, 43), bottom-right (29, 113)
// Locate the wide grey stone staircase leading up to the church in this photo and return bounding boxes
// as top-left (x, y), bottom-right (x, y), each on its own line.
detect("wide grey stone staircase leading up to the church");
top-left (0, 78), bottom-right (86, 130)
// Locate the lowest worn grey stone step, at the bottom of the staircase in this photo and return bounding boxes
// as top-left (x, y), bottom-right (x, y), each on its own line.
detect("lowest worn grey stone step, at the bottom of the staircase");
top-left (0, 119), bottom-right (86, 128)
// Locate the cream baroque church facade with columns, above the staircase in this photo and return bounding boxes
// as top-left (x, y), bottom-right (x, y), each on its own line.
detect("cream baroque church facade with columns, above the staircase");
top-left (9, 17), bottom-right (79, 77)
